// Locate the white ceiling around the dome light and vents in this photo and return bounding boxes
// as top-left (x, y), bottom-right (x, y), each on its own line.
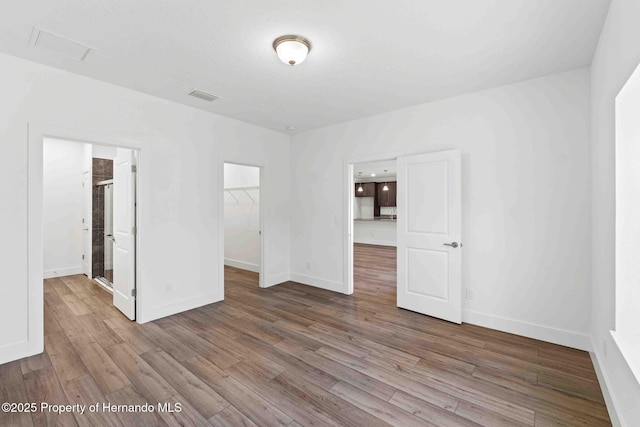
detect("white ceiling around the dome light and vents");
top-left (0, 0), bottom-right (609, 132)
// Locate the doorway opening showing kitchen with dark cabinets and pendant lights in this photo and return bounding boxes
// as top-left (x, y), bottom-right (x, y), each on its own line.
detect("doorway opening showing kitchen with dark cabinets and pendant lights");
top-left (352, 160), bottom-right (397, 305)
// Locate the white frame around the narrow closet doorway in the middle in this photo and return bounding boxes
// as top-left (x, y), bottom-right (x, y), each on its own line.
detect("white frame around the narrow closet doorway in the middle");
top-left (218, 159), bottom-right (266, 294)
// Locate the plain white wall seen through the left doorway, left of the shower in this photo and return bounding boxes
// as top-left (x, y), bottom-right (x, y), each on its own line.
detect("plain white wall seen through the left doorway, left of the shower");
top-left (42, 138), bottom-right (85, 278)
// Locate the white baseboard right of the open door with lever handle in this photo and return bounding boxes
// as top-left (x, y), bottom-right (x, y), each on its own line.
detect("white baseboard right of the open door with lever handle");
top-left (462, 310), bottom-right (591, 351)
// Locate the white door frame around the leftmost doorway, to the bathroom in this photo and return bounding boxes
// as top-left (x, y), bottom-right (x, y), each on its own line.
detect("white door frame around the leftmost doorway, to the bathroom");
top-left (25, 122), bottom-right (146, 354)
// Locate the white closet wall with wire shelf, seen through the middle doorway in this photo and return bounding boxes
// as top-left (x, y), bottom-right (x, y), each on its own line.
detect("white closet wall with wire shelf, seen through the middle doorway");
top-left (224, 163), bottom-right (260, 273)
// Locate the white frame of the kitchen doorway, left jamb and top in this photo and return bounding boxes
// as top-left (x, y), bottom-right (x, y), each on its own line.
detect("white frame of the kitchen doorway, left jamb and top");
top-left (343, 152), bottom-right (406, 295)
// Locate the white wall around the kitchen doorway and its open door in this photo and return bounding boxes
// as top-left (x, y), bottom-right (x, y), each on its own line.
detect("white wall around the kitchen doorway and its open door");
top-left (291, 69), bottom-right (591, 348)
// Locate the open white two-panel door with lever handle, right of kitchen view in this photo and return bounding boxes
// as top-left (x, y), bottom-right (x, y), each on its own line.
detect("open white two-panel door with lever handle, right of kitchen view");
top-left (397, 150), bottom-right (462, 323)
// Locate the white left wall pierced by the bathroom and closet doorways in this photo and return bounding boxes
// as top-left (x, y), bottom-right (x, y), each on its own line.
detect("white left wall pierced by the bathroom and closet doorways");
top-left (0, 55), bottom-right (290, 363)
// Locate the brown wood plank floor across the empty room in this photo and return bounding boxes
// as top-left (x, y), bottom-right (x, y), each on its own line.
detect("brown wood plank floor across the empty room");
top-left (0, 245), bottom-right (610, 427)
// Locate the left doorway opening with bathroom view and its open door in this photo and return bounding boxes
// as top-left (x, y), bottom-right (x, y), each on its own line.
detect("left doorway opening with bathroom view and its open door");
top-left (42, 137), bottom-right (138, 320)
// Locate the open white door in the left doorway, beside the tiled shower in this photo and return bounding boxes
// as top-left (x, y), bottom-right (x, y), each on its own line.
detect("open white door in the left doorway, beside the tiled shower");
top-left (113, 148), bottom-right (136, 320)
